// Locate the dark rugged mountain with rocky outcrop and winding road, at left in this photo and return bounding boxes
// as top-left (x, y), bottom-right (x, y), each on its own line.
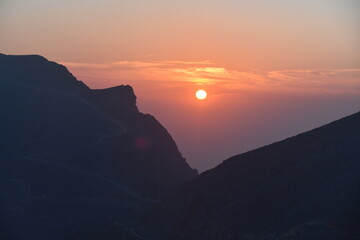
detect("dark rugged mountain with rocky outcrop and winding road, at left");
top-left (0, 54), bottom-right (198, 239)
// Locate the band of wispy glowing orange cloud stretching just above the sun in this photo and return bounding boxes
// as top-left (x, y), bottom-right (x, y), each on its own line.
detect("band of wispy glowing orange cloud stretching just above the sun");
top-left (62, 61), bottom-right (360, 93)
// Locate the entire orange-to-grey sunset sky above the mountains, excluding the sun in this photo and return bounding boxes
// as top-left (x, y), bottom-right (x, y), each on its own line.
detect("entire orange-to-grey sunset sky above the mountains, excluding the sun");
top-left (0, 0), bottom-right (360, 171)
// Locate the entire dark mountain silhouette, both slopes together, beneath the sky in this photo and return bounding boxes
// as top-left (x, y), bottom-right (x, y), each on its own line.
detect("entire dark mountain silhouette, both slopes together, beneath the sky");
top-left (0, 54), bottom-right (360, 240)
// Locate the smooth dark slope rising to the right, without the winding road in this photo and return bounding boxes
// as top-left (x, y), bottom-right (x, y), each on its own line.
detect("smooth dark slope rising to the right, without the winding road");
top-left (137, 113), bottom-right (360, 240)
